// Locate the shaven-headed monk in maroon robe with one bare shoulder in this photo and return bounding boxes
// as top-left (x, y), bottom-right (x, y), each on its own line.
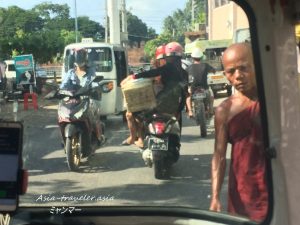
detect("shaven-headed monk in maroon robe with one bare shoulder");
top-left (210, 43), bottom-right (268, 221)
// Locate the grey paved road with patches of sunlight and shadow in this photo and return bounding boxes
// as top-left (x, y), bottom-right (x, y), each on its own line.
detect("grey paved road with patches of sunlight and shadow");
top-left (2, 94), bottom-right (231, 212)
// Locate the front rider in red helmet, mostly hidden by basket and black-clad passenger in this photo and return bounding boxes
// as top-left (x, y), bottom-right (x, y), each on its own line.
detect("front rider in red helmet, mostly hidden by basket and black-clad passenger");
top-left (121, 45), bottom-right (169, 148)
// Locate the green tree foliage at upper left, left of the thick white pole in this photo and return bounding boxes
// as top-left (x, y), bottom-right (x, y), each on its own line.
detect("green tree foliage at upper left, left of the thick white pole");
top-left (0, 3), bottom-right (104, 63)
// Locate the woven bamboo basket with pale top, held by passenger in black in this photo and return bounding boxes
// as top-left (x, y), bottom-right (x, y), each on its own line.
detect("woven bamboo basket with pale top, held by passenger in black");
top-left (122, 79), bottom-right (156, 112)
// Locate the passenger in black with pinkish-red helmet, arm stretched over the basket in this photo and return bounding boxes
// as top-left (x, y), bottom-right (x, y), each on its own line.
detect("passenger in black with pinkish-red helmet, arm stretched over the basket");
top-left (131, 42), bottom-right (188, 131)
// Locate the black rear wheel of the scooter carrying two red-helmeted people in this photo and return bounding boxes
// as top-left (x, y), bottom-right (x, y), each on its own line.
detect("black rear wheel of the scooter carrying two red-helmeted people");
top-left (152, 151), bottom-right (169, 180)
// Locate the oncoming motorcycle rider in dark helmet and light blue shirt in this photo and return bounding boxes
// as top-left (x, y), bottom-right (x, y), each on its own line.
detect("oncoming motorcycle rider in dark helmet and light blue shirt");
top-left (60, 48), bottom-right (105, 145)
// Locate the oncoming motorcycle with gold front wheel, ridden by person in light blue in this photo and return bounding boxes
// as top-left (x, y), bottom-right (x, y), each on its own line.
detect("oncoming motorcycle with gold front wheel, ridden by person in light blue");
top-left (45, 76), bottom-right (104, 171)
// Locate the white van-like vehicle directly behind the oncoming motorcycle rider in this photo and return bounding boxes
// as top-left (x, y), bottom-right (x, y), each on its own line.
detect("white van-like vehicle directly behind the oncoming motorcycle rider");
top-left (62, 41), bottom-right (128, 116)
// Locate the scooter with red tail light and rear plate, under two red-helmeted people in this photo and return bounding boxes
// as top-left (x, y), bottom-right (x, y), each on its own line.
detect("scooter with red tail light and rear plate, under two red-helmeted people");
top-left (142, 113), bottom-right (181, 179)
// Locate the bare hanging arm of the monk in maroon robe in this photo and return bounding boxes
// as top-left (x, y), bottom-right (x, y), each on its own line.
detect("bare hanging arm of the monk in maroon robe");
top-left (210, 102), bottom-right (228, 212)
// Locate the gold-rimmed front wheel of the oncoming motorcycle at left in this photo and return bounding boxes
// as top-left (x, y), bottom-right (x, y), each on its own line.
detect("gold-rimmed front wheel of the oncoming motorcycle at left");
top-left (66, 133), bottom-right (82, 171)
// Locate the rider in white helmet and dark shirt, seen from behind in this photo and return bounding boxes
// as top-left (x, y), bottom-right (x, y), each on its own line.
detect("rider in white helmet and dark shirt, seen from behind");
top-left (186, 48), bottom-right (216, 117)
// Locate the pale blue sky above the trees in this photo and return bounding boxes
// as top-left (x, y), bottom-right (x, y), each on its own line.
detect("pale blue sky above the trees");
top-left (0, 0), bottom-right (187, 33)
